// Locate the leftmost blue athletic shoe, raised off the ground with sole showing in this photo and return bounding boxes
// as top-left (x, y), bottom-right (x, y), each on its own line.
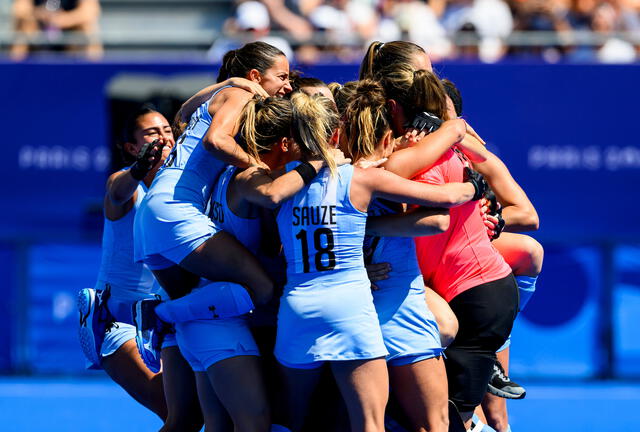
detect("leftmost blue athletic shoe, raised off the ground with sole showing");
top-left (78, 288), bottom-right (113, 366)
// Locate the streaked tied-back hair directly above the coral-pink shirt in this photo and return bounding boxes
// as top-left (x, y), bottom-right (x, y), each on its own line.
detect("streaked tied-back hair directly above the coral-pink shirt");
top-left (376, 64), bottom-right (448, 120)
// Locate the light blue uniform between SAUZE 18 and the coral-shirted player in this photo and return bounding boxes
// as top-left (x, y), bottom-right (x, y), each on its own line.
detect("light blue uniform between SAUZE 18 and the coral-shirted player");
top-left (365, 200), bottom-right (443, 366)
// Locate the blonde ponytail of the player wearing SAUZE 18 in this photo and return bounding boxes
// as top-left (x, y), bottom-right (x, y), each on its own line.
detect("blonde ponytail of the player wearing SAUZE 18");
top-left (291, 92), bottom-right (338, 175)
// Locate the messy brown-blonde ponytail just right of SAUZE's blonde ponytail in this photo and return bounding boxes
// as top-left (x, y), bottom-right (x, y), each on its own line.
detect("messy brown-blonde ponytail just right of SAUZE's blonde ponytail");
top-left (341, 79), bottom-right (391, 161)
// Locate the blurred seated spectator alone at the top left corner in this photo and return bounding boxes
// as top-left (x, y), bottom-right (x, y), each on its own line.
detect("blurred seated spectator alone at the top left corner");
top-left (10, 0), bottom-right (102, 60)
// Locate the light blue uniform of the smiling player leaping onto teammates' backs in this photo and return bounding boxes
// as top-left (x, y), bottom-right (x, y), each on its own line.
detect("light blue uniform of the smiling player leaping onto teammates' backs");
top-left (135, 87), bottom-right (232, 270)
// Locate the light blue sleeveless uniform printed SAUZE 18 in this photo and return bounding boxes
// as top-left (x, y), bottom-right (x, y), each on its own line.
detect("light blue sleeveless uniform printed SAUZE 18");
top-left (275, 164), bottom-right (387, 368)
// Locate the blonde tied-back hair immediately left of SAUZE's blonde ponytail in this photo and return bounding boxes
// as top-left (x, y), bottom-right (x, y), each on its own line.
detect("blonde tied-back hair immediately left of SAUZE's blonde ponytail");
top-left (238, 95), bottom-right (293, 160)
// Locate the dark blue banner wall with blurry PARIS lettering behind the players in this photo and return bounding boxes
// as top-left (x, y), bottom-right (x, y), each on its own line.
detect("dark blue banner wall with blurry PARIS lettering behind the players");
top-left (0, 63), bottom-right (640, 241)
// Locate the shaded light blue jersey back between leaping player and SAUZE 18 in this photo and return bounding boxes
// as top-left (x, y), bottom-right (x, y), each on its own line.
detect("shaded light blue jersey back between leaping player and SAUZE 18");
top-left (209, 166), bottom-right (261, 255)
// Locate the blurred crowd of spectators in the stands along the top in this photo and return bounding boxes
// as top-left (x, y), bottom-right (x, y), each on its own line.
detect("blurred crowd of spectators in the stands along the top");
top-left (11, 0), bottom-right (640, 63)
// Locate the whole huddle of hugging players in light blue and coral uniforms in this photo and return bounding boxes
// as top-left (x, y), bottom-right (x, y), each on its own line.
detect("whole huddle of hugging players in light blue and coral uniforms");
top-left (78, 41), bottom-right (543, 432)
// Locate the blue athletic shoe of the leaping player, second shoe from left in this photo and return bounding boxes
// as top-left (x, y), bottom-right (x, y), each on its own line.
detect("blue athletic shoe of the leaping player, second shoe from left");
top-left (133, 299), bottom-right (167, 373)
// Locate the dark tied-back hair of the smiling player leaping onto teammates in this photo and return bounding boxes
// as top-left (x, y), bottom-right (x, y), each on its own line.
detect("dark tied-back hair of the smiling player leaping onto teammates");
top-left (217, 42), bottom-right (284, 82)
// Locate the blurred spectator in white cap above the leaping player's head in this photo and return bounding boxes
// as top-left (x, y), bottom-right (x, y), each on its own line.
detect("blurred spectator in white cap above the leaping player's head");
top-left (207, 0), bottom-right (293, 63)
